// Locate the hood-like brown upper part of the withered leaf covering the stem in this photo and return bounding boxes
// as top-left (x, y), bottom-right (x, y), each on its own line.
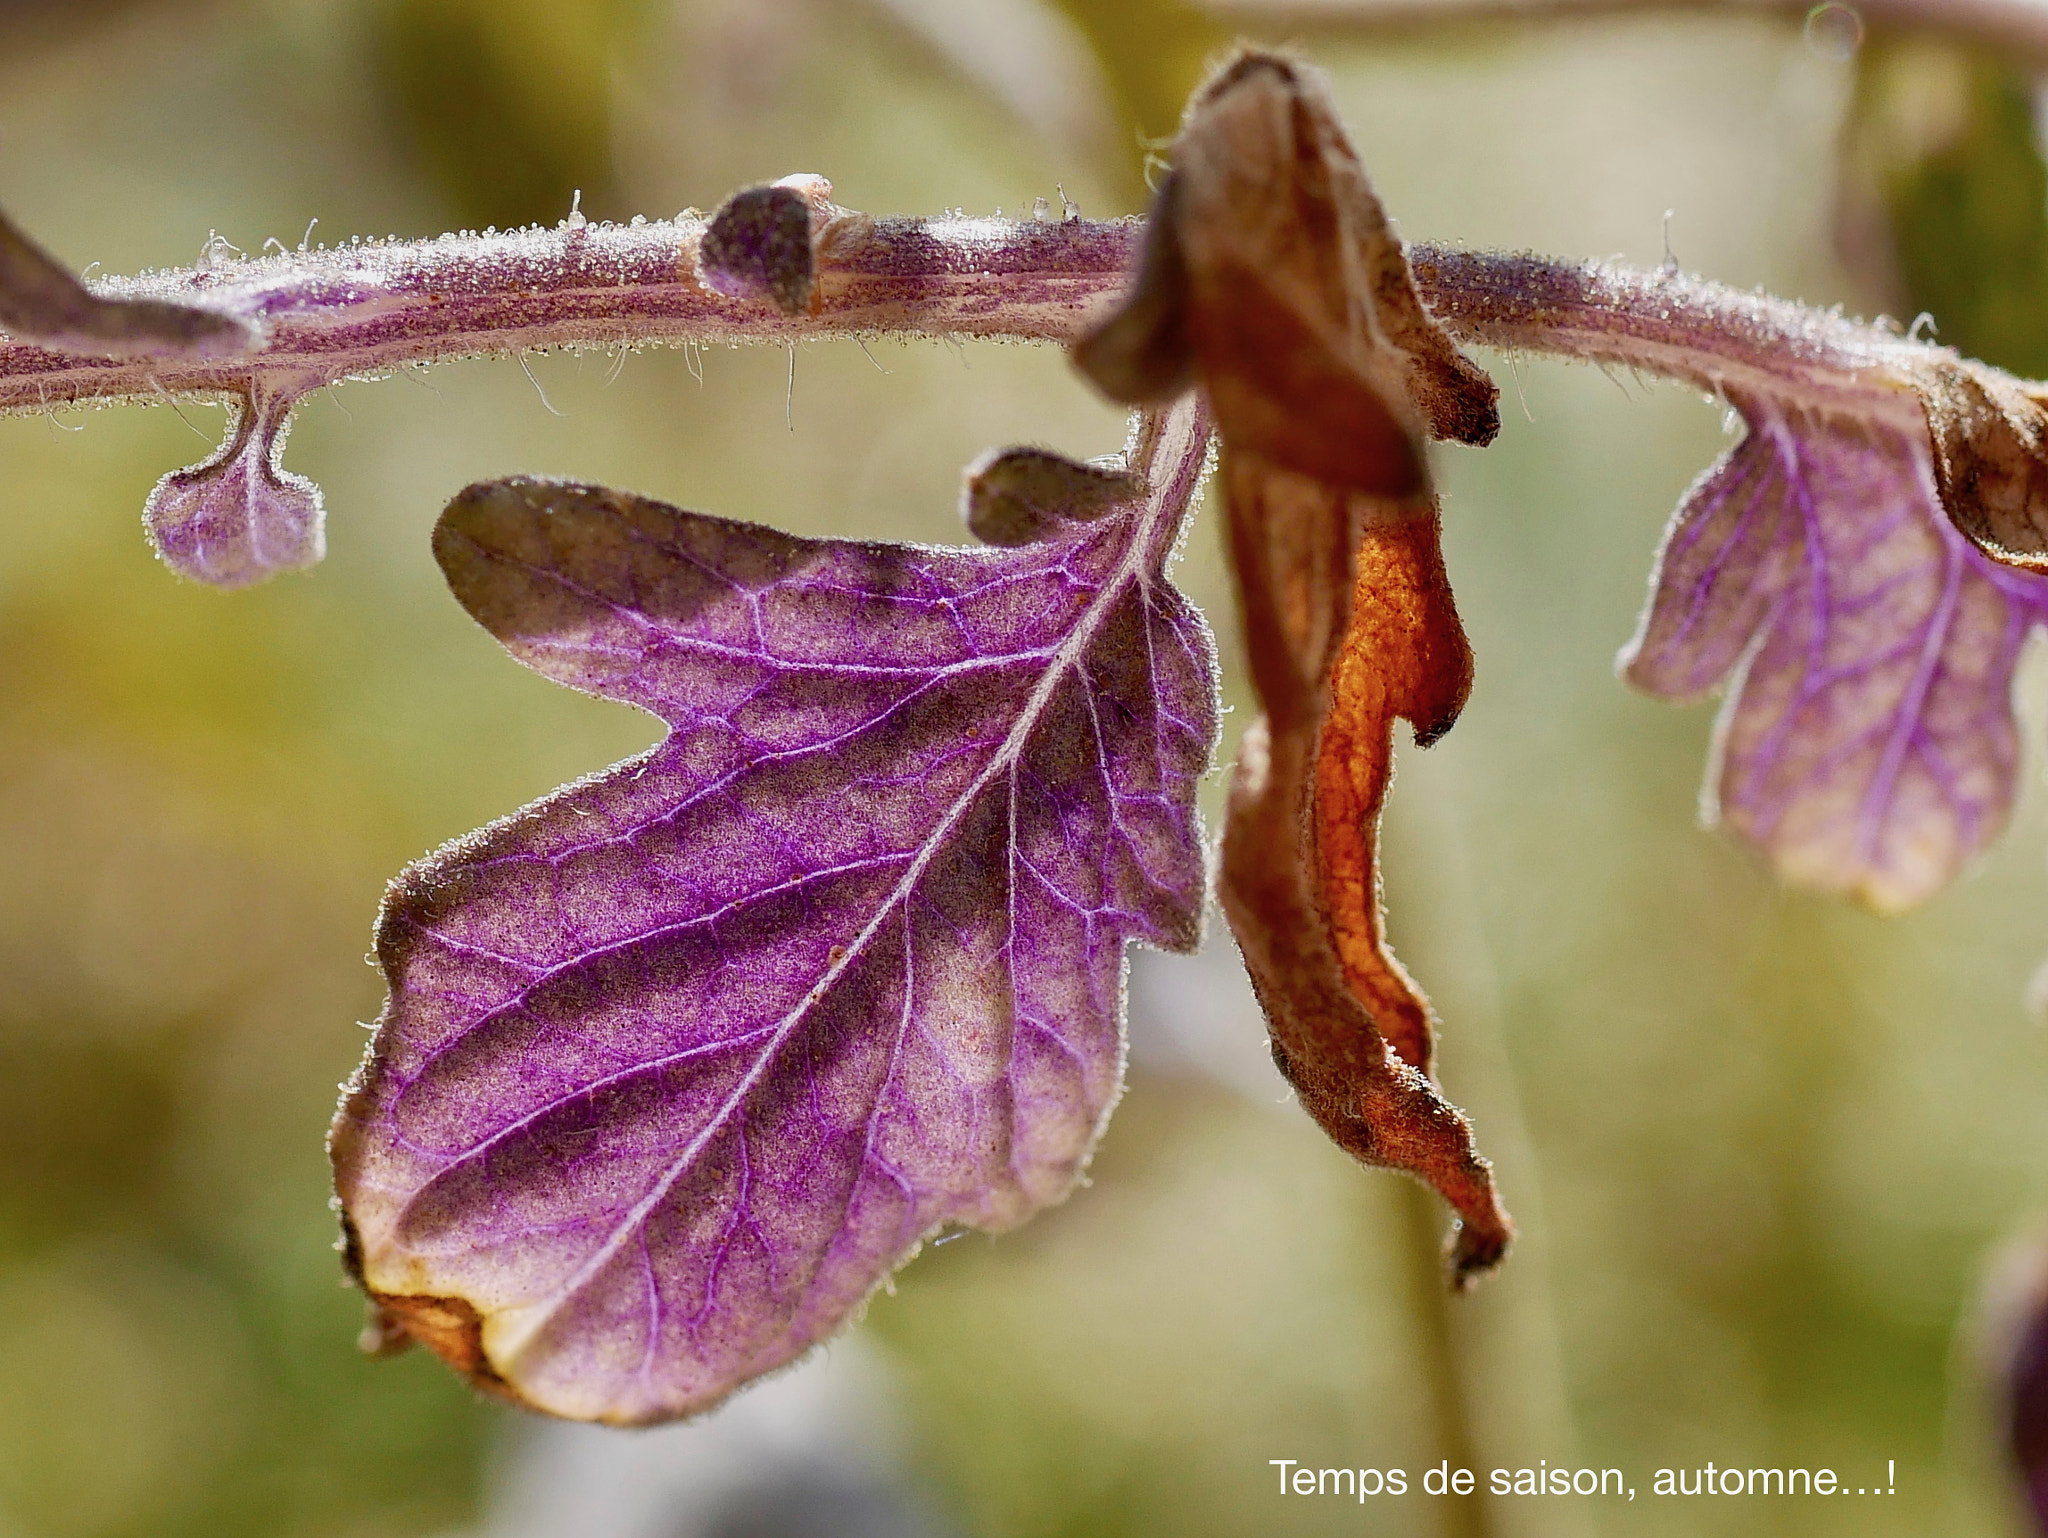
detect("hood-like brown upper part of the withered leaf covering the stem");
top-left (1073, 49), bottom-right (1499, 498)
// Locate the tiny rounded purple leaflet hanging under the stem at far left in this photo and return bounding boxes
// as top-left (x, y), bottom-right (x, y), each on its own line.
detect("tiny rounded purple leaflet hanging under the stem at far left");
top-left (141, 377), bottom-right (328, 588)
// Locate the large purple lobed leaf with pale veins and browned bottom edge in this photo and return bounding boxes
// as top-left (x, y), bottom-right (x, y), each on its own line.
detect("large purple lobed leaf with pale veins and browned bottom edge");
top-left (334, 401), bottom-right (1217, 1423)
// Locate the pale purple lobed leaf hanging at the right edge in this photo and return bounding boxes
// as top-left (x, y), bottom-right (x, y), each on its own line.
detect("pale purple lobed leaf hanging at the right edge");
top-left (1622, 397), bottom-right (2048, 913)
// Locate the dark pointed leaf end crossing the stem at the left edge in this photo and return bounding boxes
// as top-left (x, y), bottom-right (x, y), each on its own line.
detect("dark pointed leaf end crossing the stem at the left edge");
top-left (0, 202), bottom-right (256, 358)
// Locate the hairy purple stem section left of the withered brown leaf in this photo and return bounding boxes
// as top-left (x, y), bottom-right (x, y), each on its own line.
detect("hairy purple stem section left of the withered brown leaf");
top-left (0, 215), bottom-right (1141, 412)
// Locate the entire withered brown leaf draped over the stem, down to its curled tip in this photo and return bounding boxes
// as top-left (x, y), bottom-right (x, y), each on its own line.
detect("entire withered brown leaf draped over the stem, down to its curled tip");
top-left (1075, 49), bottom-right (1513, 1280)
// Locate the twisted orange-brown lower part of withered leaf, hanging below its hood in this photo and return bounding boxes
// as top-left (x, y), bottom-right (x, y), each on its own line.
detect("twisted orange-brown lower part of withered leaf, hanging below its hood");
top-left (1219, 459), bottom-right (1513, 1280)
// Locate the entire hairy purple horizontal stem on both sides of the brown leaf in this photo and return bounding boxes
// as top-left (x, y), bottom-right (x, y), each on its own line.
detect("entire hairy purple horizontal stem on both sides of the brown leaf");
top-left (0, 215), bottom-right (1937, 422)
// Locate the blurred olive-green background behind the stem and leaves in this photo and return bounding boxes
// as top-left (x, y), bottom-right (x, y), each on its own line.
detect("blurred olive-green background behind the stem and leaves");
top-left (0, 0), bottom-right (2048, 1538)
